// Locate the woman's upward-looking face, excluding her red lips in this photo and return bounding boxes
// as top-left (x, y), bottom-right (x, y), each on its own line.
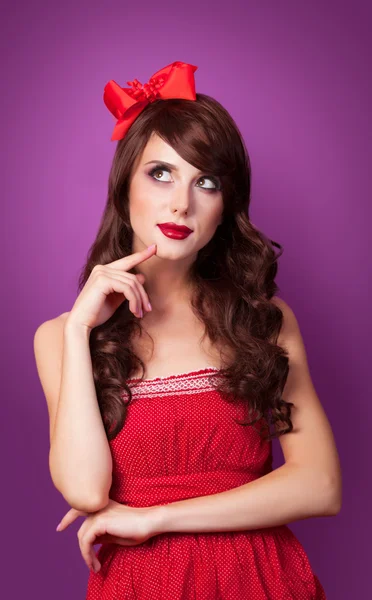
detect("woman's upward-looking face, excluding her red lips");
top-left (129, 134), bottom-right (223, 259)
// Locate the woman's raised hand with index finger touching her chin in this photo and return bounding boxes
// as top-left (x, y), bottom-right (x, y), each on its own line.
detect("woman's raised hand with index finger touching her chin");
top-left (67, 244), bottom-right (156, 330)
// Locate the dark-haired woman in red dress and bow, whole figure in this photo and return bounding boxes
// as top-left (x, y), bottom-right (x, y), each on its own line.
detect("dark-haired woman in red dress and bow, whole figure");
top-left (35, 62), bottom-right (341, 600)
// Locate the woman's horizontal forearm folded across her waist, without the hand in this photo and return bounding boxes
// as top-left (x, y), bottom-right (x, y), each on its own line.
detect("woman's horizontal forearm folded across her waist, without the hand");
top-left (153, 463), bottom-right (339, 533)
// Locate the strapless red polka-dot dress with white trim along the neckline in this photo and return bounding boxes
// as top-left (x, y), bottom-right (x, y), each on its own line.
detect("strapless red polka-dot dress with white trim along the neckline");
top-left (86, 367), bottom-right (326, 600)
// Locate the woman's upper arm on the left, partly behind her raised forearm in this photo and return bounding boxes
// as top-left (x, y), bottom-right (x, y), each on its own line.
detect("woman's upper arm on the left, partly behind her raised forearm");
top-left (34, 313), bottom-right (69, 442)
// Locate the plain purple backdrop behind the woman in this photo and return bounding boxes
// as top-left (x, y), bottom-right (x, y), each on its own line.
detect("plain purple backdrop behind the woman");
top-left (0, 0), bottom-right (372, 600)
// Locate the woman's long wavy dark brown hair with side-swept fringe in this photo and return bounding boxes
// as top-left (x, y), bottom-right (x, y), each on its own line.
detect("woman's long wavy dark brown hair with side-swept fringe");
top-left (78, 94), bottom-right (293, 440)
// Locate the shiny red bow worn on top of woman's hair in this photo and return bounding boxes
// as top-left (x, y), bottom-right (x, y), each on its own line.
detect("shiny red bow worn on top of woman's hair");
top-left (103, 62), bottom-right (198, 140)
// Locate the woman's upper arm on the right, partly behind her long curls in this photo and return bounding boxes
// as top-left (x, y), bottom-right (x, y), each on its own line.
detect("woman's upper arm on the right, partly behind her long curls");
top-left (272, 297), bottom-right (342, 504)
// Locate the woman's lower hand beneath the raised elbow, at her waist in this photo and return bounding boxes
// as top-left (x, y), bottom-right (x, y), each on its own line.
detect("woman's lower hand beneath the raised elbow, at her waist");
top-left (58, 499), bottom-right (160, 572)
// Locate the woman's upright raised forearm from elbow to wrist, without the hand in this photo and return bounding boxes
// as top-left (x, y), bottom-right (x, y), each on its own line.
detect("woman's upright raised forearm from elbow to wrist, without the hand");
top-left (49, 319), bottom-right (112, 512)
